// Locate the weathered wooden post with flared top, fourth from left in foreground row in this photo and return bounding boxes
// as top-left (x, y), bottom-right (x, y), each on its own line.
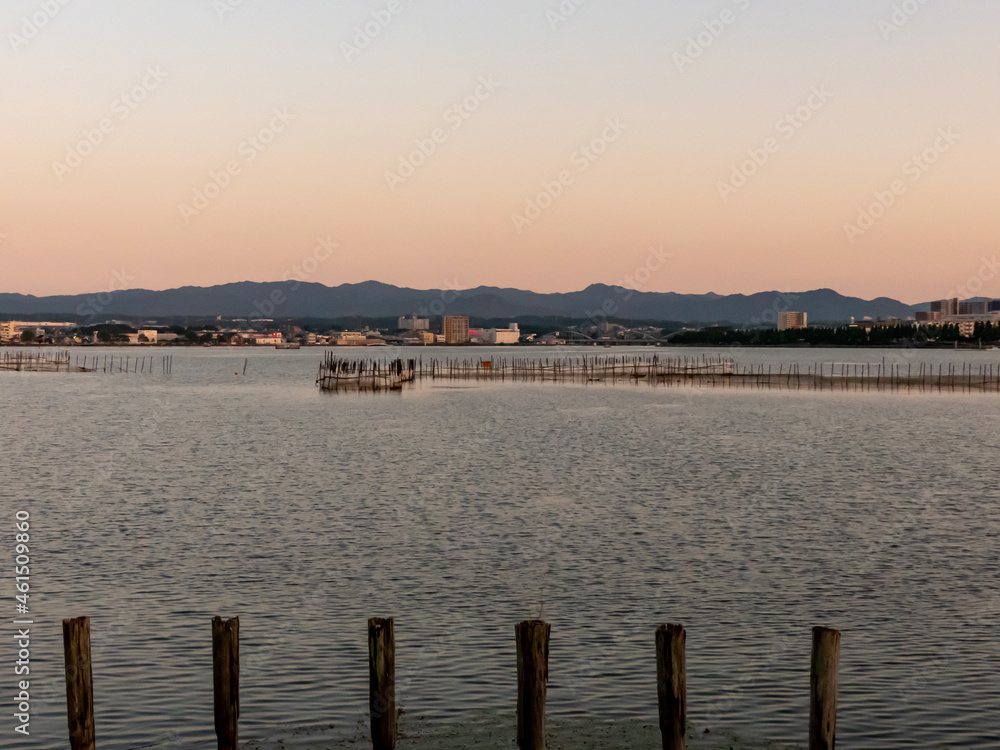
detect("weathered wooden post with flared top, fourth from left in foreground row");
top-left (514, 620), bottom-right (552, 750)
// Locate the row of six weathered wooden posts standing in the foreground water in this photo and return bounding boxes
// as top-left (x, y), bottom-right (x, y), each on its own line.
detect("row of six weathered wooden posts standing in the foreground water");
top-left (63, 617), bottom-right (840, 750)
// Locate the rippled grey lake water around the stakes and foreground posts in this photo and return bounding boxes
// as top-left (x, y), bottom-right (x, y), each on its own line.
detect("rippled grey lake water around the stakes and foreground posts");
top-left (0, 348), bottom-right (1000, 748)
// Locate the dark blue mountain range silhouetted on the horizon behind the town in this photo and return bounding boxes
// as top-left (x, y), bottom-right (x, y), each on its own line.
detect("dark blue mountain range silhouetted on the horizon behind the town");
top-left (0, 281), bottom-right (924, 325)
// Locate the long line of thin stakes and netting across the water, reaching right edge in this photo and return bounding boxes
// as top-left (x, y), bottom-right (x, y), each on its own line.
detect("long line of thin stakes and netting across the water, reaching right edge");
top-left (316, 352), bottom-right (1000, 393)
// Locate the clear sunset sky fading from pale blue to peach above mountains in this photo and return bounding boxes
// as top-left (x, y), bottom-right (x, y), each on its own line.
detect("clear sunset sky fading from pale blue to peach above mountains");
top-left (0, 0), bottom-right (1000, 303)
